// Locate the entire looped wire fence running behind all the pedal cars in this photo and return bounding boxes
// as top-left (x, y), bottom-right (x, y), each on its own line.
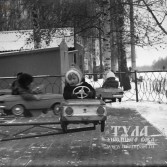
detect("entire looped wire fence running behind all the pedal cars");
top-left (0, 71), bottom-right (167, 103)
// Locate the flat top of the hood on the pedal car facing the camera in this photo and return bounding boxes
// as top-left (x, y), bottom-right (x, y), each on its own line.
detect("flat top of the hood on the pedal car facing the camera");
top-left (62, 99), bottom-right (105, 106)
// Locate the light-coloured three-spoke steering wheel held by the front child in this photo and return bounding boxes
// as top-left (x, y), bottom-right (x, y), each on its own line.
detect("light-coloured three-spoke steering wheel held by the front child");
top-left (73, 86), bottom-right (90, 99)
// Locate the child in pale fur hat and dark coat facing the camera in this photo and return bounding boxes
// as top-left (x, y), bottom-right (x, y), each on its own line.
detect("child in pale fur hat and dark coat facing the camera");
top-left (63, 65), bottom-right (95, 100)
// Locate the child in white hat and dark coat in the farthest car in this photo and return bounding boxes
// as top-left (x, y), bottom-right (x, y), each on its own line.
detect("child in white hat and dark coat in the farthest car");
top-left (102, 71), bottom-right (119, 88)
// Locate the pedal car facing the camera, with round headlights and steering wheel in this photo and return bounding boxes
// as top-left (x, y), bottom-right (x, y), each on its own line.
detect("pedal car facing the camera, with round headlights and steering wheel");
top-left (60, 86), bottom-right (107, 132)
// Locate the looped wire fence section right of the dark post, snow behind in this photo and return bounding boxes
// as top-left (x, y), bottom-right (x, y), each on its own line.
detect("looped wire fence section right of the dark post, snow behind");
top-left (131, 71), bottom-right (167, 103)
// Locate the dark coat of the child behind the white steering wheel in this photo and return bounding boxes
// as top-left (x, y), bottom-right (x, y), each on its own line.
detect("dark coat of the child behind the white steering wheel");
top-left (63, 81), bottom-right (96, 100)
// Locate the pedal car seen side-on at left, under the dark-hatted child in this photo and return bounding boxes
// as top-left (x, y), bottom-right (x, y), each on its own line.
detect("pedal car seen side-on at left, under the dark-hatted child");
top-left (0, 88), bottom-right (63, 116)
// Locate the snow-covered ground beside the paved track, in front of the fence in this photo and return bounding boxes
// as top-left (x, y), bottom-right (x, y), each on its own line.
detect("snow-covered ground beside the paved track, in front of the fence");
top-left (107, 101), bottom-right (167, 136)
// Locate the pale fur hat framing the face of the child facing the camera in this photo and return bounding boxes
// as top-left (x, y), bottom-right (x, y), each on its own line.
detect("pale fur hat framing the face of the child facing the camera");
top-left (65, 65), bottom-right (83, 83)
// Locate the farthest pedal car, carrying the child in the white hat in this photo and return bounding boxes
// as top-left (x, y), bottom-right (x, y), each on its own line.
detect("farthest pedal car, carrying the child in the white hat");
top-left (96, 88), bottom-right (124, 102)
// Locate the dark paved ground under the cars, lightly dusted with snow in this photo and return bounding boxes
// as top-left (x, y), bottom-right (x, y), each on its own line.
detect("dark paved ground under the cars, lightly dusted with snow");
top-left (0, 107), bottom-right (167, 167)
